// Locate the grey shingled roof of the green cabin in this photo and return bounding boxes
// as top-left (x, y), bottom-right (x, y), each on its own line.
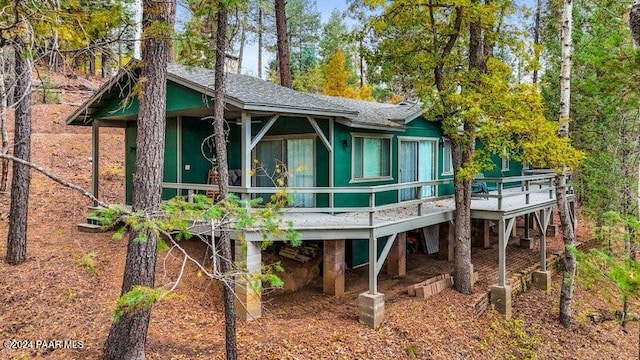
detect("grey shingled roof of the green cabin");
top-left (67, 64), bottom-right (421, 129)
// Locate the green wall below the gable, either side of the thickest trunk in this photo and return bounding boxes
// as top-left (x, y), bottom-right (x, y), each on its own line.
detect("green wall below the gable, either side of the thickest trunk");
top-left (125, 118), bottom-right (178, 204)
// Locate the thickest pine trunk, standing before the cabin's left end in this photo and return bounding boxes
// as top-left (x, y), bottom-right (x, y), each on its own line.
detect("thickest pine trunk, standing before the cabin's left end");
top-left (104, 0), bottom-right (170, 360)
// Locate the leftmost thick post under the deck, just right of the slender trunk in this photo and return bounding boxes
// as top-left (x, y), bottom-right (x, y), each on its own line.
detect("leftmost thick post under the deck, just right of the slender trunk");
top-left (235, 240), bottom-right (262, 321)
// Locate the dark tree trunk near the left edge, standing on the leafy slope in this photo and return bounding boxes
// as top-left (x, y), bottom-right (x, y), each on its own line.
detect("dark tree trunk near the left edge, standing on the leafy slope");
top-left (6, 31), bottom-right (31, 265)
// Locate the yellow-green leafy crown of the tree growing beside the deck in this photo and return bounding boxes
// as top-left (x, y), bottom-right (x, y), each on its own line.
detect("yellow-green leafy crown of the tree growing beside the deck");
top-left (365, 0), bottom-right (582, 181)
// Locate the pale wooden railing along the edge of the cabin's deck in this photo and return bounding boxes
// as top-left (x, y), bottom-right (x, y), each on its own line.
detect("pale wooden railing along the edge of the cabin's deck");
top-left (162, 171), bottom-right (568, 226)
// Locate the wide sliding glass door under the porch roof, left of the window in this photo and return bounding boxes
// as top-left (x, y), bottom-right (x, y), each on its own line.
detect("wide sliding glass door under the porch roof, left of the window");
top-left (254, 138), bottom-right (315, 207)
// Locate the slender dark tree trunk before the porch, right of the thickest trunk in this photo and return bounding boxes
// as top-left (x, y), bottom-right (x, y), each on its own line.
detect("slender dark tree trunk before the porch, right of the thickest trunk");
top-left (213, 0), bottom-right (238, 360)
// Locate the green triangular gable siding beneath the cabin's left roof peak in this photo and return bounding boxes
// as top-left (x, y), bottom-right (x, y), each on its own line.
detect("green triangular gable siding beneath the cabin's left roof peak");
top-left (94, 81), bottom-right (212, 119)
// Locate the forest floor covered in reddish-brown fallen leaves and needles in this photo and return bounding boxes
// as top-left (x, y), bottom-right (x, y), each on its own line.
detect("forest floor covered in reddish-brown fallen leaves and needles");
top-left (0, 74), bottom-right (639, 359)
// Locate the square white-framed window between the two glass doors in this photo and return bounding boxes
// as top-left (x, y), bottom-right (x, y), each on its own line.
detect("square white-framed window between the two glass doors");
top-left (352, 135), bottom-right (391, 180)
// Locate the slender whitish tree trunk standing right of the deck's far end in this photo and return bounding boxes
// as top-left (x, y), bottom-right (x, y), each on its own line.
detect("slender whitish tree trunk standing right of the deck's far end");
top-left (556, 0), bottom-right (577, 328)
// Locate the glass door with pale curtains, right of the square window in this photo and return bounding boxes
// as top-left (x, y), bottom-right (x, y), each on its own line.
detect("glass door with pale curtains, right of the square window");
top-left (399, 140), bottom-right (437, 201)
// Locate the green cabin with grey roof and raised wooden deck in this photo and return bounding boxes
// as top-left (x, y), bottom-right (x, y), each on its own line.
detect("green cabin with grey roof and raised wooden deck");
top-left (67, 64), bottom-right (555, 327)
